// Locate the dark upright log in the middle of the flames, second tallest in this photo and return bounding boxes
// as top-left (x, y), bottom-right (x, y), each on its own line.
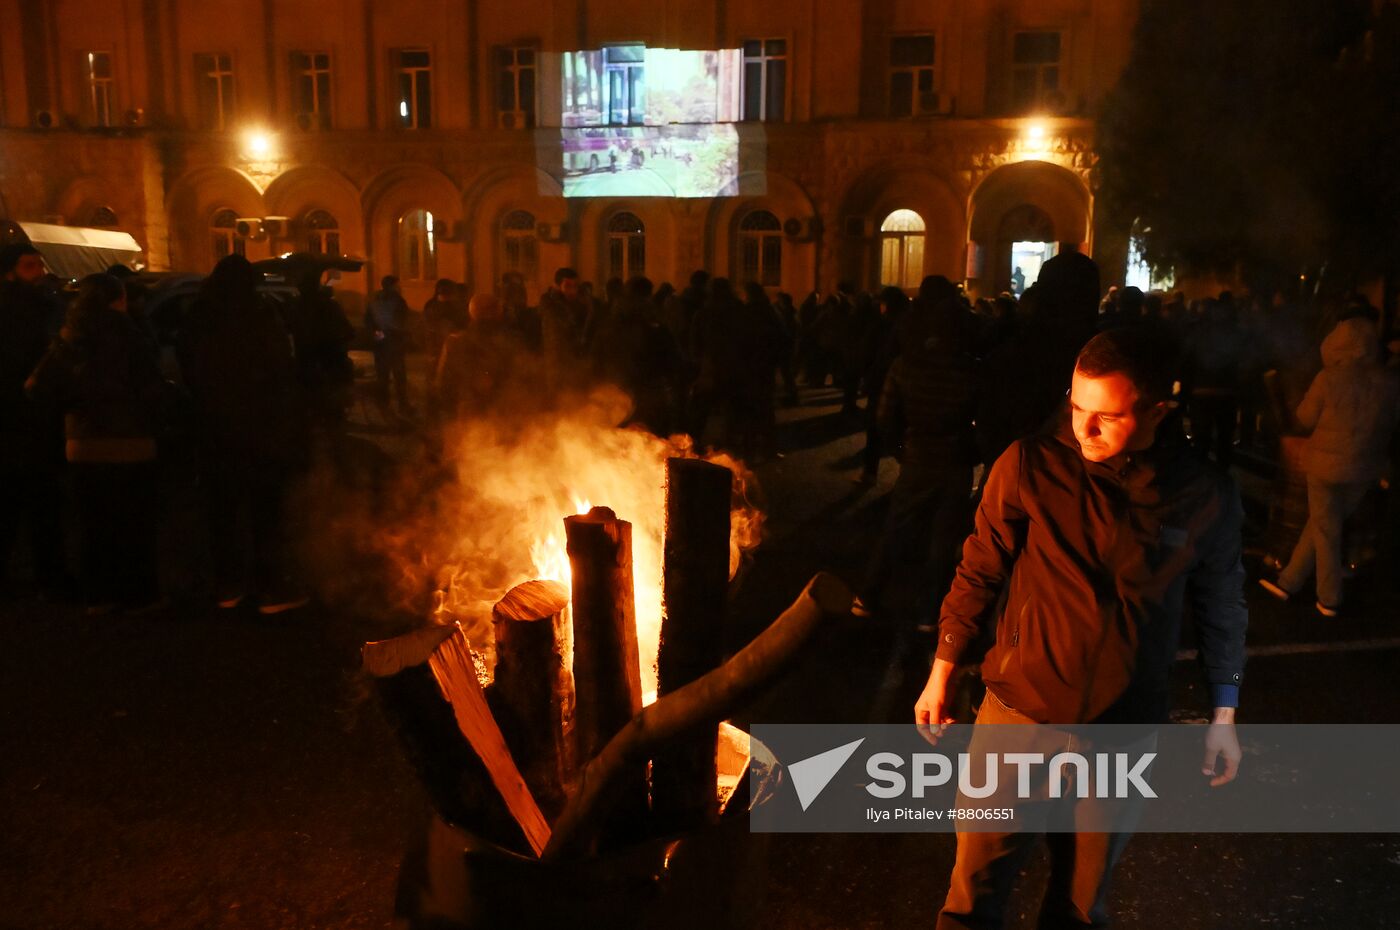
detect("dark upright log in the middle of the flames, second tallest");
top-left (564, 507), bottom-right (641, 759)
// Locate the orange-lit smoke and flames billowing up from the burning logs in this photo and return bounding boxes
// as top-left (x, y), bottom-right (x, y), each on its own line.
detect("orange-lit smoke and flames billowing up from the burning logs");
top-left (310, 387), bottom-right (763, 690)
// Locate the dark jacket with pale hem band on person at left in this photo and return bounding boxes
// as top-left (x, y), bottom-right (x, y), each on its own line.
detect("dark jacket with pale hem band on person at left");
top-left (25, 310), bottom-right (164, 462)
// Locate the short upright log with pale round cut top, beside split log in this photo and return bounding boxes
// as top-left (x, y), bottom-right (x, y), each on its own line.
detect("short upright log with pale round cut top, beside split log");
top-left (487, 581), bottom-right (575, 814)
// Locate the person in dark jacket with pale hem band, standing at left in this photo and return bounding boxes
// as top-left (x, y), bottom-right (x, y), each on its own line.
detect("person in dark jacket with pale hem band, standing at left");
top-left (25, 275), bottom-right (164, 615)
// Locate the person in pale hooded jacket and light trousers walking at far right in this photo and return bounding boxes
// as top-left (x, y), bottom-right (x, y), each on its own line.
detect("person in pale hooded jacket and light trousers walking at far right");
top-left (1260, 317), bottom-right (1400, 616)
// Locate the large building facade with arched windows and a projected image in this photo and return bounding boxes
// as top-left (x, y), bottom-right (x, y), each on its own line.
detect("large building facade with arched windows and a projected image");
top-left (0, 0), bottom-right (1137, 308)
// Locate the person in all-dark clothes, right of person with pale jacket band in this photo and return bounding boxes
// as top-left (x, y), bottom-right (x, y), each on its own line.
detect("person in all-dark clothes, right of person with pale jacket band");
top-left (178, 255), bottom-right (309, 613)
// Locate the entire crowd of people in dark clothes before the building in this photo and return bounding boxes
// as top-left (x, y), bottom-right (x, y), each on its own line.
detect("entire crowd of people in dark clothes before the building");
top-left (0, 239), bottom-right (1397, 629)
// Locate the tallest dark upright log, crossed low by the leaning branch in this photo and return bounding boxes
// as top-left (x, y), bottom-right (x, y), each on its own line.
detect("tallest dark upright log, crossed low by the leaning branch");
top-left (651, 458), bottom-right (734, 829)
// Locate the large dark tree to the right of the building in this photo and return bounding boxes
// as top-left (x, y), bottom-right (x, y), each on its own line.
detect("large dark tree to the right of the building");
top-left (1098, 0), bottom-right (1400, 298)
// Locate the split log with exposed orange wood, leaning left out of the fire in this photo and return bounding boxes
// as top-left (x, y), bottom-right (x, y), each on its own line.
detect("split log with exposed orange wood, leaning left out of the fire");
top-left (363, 626), bottom-right (550, 854)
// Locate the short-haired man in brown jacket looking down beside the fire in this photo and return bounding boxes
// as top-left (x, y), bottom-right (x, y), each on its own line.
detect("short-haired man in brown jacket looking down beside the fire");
top-left (914, 328), bottom-right (1247, 930)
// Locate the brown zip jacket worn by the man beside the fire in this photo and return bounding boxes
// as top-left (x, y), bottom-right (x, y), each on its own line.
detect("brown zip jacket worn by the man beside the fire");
top-left (938, 414), bottom-right (1247, 724)
